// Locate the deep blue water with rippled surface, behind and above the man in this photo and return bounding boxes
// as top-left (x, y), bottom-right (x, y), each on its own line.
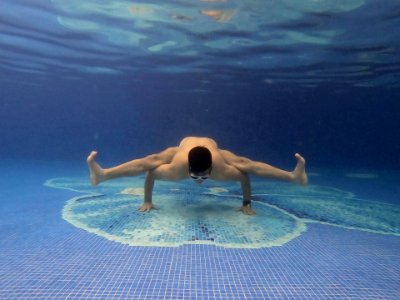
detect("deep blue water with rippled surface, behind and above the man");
top-left (0, 0), bottom-right (400, 169)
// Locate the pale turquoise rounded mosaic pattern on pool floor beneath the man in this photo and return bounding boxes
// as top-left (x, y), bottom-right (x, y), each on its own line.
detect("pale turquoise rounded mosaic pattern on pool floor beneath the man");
top-left (46, 178), bottom-right (400, 248)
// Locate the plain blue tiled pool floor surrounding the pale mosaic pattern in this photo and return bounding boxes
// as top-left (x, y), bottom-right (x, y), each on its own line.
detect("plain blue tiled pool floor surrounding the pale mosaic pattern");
top-left (0, 162), bottom-right (400, 299)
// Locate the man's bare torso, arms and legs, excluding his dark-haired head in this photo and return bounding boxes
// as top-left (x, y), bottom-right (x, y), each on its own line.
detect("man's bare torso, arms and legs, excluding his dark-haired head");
top-left (87, 137), bottom-right (308, 215)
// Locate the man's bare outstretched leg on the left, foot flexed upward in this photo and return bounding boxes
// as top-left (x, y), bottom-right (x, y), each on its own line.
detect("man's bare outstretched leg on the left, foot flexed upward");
top-left (86, 147), bottom-right (177, 185)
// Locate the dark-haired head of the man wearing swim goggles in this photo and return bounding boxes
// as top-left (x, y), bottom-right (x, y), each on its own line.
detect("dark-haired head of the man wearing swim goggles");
top-left (188, 146), bottom-right (212, 183)
